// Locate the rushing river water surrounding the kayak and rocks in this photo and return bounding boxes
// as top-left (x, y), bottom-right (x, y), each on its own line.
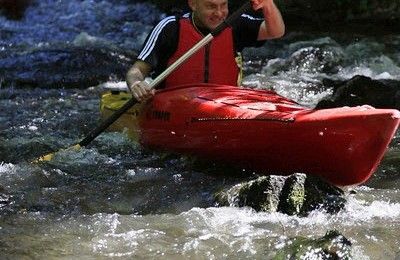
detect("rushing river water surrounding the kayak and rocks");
top-left (0, 1), bottom-right (400, 259)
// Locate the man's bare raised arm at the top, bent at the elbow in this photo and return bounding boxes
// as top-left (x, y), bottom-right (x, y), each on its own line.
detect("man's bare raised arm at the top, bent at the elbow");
top-left (252, 0), bottom-right (285, 41)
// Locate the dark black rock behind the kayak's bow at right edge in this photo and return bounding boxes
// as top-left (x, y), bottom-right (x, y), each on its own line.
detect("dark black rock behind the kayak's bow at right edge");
top-left (316, 75), bottom-right (400, 109)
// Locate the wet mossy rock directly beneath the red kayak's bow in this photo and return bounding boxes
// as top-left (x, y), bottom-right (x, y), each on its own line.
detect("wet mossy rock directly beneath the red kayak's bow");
top-left (215, 173), bottom-right (346, 216)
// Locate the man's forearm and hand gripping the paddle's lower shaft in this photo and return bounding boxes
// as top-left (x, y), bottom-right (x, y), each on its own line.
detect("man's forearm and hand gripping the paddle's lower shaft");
top-left (126, 60), bottom-right (155, 102)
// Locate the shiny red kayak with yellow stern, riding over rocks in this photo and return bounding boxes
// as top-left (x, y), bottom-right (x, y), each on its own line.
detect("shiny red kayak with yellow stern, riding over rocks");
top-left (101, 84), bottom-right (400, 186)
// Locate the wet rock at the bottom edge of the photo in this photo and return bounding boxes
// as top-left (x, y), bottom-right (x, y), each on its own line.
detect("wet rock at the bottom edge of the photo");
top-left (273, 230), bottom-right (352, 260)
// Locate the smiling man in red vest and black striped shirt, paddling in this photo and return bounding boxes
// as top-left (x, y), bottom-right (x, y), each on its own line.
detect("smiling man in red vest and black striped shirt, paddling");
top-left (126, 0), bottom-right (285, 101)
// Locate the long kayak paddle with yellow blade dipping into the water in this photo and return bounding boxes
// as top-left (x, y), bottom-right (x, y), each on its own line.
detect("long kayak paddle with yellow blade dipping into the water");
top-left (34, 0), bottom-right (251, 162)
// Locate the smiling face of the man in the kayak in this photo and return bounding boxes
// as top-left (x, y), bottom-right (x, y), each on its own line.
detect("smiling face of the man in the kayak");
top-left (189, 0), bottom-right (229, 30)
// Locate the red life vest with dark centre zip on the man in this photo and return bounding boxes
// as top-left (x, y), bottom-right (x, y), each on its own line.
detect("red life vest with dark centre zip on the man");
top-left (165, 18), bottom-right (240, 88)
